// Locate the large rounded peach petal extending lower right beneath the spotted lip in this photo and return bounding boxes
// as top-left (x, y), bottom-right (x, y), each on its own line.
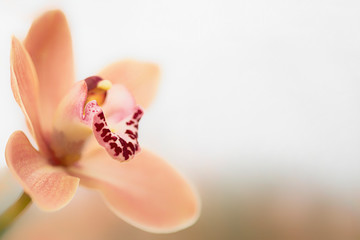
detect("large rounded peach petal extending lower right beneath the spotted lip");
top-left (69, 150), bottom-right (200, 232)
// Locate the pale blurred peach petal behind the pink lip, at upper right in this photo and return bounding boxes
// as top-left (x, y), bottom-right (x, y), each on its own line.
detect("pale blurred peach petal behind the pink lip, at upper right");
top-left (98, 60), bottom-right (160, 108)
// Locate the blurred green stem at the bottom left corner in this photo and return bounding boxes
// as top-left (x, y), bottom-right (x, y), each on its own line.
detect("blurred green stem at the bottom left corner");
top-left (0, 192), bottom-right (31, 237)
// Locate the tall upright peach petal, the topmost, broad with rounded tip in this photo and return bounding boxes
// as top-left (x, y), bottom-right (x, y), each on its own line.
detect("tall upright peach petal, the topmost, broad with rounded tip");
top-left (24, 10), bottom-right (75, 138)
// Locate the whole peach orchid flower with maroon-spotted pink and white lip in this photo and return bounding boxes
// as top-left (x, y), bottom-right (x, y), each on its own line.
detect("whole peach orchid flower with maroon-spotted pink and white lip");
top-left (5, 10), bottom-right (200, 232)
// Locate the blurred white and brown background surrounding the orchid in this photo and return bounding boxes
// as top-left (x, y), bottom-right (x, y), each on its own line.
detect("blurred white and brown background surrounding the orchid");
top-left (0, 0), bottom-right (360, 240)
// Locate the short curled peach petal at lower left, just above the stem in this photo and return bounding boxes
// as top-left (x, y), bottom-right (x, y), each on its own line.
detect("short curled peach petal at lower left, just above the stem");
top-left (5, 131), bottom-right (79, 211)
